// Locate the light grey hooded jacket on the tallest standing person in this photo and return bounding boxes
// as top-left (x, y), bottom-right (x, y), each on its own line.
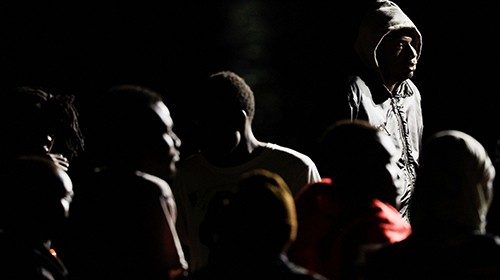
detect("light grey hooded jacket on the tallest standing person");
top-left (347, 0), bottom-right (423, 217)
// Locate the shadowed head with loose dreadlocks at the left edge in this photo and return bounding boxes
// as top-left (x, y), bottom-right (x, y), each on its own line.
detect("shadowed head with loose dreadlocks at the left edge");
top-left (0, 87), bottom-right (83, 162)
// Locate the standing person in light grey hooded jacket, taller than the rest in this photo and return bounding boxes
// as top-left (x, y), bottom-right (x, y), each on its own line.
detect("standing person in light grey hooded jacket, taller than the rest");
top-left (347, 1), bottom-right (423, 220)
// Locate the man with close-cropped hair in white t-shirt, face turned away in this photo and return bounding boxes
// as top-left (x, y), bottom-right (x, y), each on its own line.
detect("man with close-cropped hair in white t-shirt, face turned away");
top-left (173, 71), bottom-right (320, 271)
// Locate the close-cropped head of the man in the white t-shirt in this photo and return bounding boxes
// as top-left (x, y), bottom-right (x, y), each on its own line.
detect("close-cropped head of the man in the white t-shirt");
top-left (197, 71), bottom-right (255, 158)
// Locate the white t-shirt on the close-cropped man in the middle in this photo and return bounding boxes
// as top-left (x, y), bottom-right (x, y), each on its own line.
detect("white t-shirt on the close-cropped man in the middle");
top-left (173, 143), bottom-right (321, 272)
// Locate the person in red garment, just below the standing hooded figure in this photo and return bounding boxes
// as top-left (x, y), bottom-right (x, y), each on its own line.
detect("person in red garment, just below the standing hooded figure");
top-left (289, 120), bottom-right (411, 279)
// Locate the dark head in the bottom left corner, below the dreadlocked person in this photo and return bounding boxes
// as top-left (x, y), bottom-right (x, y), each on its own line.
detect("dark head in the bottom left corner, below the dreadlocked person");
top-left (0, 156), bottom-right (73, 242)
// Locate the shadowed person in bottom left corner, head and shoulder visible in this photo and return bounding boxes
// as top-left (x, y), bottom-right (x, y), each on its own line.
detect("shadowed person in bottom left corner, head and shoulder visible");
top-left (0, 156), bottom-right (73, 280)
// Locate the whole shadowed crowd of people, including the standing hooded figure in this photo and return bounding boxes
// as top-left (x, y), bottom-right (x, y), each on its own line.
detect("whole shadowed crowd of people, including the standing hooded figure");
top-left (0, 0), bottom-right (500, 280)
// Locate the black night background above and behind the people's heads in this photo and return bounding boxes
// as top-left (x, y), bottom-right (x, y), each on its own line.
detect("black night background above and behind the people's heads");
top-left (0, 0), bottom-right (500, 206)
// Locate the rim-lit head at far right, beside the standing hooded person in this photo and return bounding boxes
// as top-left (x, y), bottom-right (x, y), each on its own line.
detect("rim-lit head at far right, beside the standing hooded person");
top-left (409, 130), bottom-right (495, 235)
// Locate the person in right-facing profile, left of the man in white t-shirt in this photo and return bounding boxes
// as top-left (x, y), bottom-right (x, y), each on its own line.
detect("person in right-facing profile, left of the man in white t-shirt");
top-left (65, 85), bottom-right (187, 279)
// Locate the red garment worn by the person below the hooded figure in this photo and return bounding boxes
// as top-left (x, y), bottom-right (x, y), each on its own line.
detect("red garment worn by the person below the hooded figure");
top-left (289, 180), bottom-right (411, 279)
